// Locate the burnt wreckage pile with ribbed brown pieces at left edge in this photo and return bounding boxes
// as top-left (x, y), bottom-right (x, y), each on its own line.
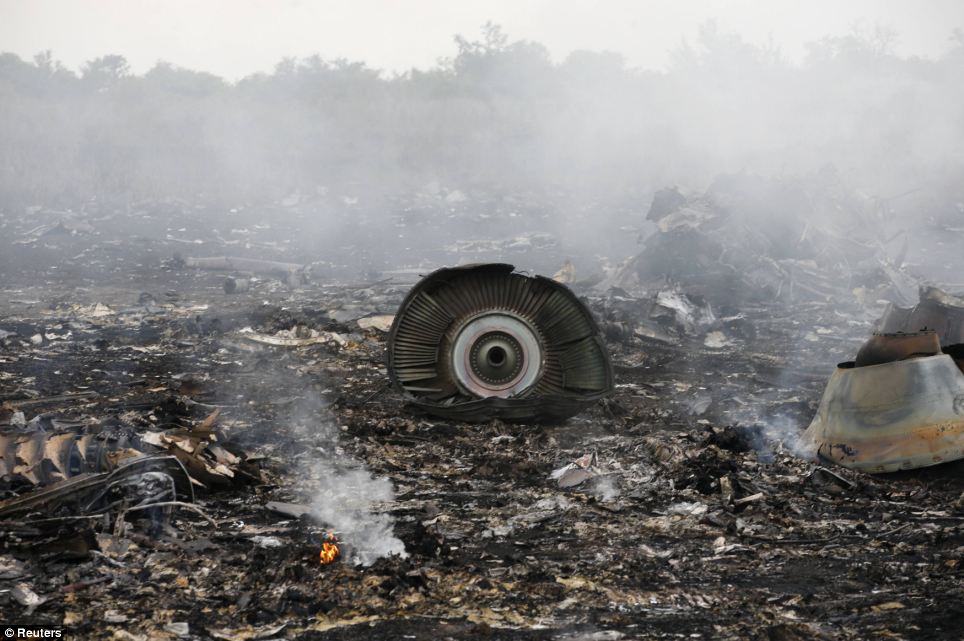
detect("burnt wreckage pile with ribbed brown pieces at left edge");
top-left (0, 396), bottom-right (262, 551)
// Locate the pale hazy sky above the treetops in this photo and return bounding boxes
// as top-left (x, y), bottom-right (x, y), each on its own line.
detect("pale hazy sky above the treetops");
top-left (0, 0), bottom-right (964, 80)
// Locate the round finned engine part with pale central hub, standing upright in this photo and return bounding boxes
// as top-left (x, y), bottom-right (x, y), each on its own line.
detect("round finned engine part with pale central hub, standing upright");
top-left (387, 264), bottom-right (613, 422)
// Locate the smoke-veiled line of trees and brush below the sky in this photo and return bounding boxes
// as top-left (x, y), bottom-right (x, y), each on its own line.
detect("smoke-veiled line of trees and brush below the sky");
top-left (0, 23), bottom-right (964, 206)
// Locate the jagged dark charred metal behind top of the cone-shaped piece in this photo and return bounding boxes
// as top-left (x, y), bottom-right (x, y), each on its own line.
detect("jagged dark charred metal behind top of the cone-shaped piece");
top-left (877, 286), bottom-right (964, 346)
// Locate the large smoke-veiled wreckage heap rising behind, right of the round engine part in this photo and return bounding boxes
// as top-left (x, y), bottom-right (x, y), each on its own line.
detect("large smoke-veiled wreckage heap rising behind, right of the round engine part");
top-left (598, 171), bottom-right (916, 306)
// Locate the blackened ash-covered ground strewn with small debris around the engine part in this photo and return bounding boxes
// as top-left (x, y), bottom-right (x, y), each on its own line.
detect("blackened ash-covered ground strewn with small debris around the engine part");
top-left (0, 206), bottom-right (964, 640)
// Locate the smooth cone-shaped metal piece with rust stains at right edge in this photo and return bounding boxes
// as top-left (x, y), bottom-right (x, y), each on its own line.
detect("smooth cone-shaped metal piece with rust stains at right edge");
top-left (804, 354), bottom-right (964, 473)
